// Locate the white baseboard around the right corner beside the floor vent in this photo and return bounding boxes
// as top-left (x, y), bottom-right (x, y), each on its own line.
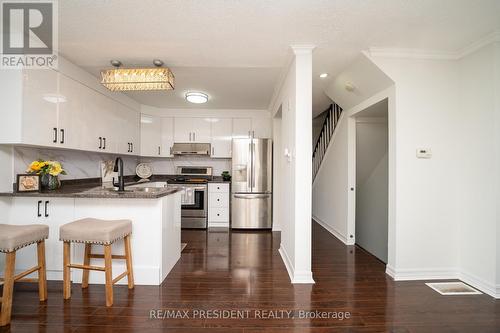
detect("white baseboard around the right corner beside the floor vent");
top-left (385, 265), bottom-right (500, 299)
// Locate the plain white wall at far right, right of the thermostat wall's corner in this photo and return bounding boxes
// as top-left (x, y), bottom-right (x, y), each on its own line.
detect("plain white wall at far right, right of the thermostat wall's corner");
top-left (455, 44), bottom-right (500, 289)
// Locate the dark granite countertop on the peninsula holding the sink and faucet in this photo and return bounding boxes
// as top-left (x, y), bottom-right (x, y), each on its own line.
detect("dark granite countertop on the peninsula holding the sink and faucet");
top-left (0, 177), bottom-right (182, 199)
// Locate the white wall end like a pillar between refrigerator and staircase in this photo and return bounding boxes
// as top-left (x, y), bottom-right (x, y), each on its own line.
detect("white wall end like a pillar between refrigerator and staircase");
top-left (271, 47), bottom-right (314, 283)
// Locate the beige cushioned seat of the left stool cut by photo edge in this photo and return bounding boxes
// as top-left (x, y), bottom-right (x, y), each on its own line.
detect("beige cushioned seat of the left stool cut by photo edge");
top-left (0, 224), bottom-right (49, 252)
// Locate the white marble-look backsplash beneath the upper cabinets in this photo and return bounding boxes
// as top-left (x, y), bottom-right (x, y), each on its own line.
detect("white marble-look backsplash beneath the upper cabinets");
top-left (14, 147), bottom-right (231, 180)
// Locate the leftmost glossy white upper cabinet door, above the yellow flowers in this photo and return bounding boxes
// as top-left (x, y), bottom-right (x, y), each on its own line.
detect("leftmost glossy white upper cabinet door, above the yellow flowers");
top-left (22, 69), bottom-right (59, 147)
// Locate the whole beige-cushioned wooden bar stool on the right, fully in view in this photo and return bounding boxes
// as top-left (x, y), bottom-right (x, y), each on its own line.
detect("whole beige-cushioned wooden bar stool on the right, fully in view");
top-left (59, 218), bottom-right (134, 306)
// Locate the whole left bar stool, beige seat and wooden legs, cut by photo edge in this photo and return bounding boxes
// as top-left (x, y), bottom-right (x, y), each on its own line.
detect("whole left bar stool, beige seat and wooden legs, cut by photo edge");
top-left (0, 224), bottom-right (49, 326)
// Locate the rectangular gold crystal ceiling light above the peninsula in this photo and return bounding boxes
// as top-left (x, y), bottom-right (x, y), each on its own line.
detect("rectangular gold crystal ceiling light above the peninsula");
top-left (101, 59), bottom-right (175, 91)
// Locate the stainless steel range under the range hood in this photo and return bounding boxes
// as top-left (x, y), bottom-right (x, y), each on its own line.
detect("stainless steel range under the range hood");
top-left (168, 166), bottom-right (213, 229)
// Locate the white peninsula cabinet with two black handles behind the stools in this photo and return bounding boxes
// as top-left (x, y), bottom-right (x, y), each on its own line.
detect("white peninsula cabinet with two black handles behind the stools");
top-left (8, 197), bottom-right (75, 280)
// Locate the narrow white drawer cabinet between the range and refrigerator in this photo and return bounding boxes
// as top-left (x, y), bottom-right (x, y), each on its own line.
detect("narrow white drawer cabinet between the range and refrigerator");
top-left (208, 183), bottom-right (230, 228)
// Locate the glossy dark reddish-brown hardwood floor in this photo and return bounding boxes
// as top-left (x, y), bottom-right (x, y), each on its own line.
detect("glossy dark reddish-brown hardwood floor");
top-left (0, 220), bottom-right (500, 333)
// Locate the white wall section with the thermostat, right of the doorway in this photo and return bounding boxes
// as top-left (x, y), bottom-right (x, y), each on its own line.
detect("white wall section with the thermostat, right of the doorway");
top-left (368, 57), bottom-right (459, 278)
